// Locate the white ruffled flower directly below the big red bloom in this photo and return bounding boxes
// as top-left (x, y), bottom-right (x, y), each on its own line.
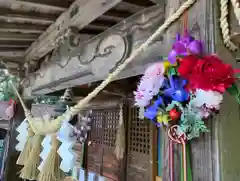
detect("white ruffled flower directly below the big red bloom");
top-left (192, 89), bottom-right (223, 110)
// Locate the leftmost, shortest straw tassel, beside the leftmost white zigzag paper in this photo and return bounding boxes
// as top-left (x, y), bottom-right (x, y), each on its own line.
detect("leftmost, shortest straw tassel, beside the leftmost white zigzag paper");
top-left (17, 128), bottom-right (34, 165)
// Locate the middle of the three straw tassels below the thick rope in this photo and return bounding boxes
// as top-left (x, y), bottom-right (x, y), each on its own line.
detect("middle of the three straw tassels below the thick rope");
top-left (20, 135), bottom-right (44, 180)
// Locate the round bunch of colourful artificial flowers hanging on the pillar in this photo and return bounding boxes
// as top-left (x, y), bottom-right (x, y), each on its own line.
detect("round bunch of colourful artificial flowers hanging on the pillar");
top-left (134, 34), bottom-right (239, 140)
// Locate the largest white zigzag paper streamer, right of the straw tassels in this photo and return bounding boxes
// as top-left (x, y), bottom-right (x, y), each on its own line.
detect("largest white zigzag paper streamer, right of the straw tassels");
top-left (57, 121), bottom-right (77, 172)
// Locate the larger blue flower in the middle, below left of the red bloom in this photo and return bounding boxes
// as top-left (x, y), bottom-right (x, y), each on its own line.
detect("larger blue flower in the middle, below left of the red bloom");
top-left (163, 76), bottom-right (189, 102)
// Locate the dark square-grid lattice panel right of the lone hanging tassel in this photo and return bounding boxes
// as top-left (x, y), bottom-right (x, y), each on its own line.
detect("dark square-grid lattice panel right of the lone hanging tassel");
top-left (128, 107), bottom-right (150, 154)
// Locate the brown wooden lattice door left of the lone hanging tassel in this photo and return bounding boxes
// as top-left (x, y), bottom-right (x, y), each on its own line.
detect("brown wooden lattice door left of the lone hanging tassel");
top-left (87, 107), bottom-right (120, 181)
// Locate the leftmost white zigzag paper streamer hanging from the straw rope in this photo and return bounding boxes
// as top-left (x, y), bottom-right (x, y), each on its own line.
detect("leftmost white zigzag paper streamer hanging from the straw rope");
top-left (15, 118), bottom-right (28, 151)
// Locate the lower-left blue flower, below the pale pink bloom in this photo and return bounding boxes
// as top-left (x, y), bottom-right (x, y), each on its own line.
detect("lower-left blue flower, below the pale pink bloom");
top-left (144, 96), bottom-right (164, 120)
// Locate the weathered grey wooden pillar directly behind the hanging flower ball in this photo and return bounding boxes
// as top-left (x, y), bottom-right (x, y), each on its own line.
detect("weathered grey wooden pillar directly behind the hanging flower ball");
top-left (163, 0), bottom-right (218, 181)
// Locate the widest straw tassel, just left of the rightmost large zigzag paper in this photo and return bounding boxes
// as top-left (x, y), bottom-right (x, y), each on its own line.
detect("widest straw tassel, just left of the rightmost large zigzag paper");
top-left (38, 135), bottom-right (64, 181)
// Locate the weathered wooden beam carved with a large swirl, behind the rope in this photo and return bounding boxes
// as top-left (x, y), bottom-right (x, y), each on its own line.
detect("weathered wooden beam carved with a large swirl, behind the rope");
top-left (21, 5), bottom-right (168, 95)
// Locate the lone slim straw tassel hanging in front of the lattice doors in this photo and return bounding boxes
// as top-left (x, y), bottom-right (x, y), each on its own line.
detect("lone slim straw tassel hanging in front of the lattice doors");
top-left (114, 104), bottom-right (125, 160)
